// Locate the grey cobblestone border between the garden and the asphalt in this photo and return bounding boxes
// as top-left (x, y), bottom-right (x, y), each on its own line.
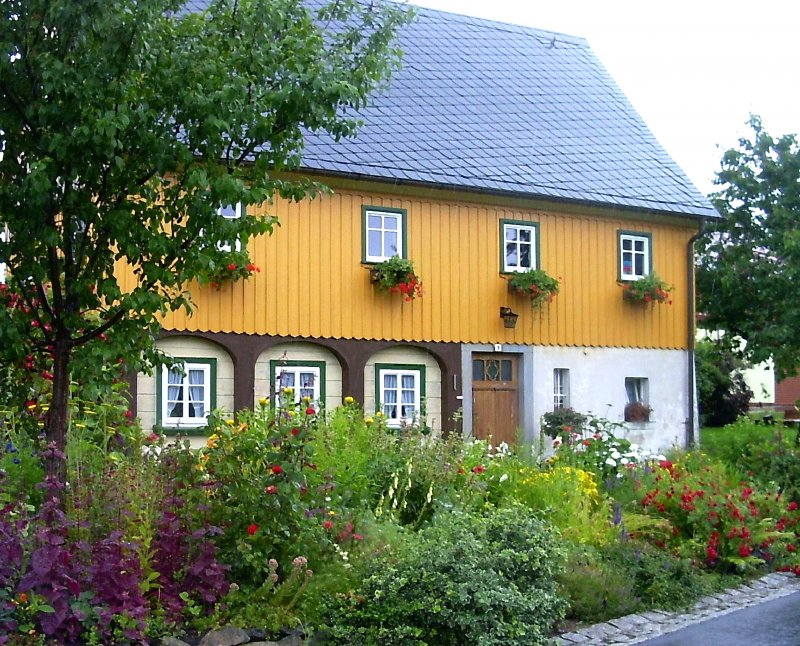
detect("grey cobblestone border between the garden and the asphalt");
top-left (552, 572), bottom-right (800, 646)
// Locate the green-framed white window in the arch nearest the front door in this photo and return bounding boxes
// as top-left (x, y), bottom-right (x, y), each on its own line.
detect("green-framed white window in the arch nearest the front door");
top-left (375, 363), bottom-right (425, 428)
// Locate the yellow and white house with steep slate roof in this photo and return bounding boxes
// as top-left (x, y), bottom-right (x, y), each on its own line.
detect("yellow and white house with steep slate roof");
top-left (133, 2), bottom-right (718, 448)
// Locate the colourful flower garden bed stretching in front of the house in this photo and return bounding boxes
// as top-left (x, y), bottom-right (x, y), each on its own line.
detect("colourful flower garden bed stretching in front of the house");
top-left (0, 398), bottom-right (800, 645)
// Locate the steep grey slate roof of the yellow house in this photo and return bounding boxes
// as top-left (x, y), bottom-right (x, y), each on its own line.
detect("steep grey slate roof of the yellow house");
top-left (303, 8), bottom-right (717, 217)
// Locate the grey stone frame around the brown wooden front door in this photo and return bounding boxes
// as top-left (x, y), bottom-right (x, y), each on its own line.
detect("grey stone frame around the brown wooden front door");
top-left (461, 343), bottom-right (536, 443)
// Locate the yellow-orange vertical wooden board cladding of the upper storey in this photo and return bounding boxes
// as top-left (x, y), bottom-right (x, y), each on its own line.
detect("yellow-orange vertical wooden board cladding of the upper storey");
top-left (139, 177), bottom-right (697, 348)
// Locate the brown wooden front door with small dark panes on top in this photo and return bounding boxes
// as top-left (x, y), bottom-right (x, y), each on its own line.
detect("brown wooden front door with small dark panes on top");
top-left (472, 353), bottom-right (519, 446)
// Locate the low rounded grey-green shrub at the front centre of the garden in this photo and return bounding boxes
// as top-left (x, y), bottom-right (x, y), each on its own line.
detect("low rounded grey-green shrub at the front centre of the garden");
top-left (322, 507), bottom-right (565, 645)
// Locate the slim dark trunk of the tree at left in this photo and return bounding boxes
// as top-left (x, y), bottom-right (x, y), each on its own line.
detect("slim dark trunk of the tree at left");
top-left (45, 334), bottom-right (72, 484)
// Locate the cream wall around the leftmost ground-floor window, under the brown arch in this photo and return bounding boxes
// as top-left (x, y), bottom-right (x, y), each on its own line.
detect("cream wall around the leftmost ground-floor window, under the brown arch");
top-left (136, 336), bottom-right (233, 431)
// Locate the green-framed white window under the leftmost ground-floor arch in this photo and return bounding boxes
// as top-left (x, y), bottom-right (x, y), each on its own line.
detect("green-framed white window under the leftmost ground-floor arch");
top-left (156, 357), bottom-right (217, 434)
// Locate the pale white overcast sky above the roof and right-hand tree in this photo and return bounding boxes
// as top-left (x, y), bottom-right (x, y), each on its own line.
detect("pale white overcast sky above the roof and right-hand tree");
top-left (411, 0), bottom-right (800, 194)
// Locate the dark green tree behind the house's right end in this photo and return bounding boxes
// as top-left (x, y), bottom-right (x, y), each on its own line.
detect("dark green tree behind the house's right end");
top-left (697, 117), bottom-right (800, 378)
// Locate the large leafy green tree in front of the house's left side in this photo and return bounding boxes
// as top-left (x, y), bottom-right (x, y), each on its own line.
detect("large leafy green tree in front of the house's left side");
top-left (0, 0), bottom-right (408, 477)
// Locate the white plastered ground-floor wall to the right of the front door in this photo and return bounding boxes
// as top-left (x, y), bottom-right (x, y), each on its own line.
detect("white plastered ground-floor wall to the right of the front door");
top-left (533, 347), bottom-right (689, 451)
